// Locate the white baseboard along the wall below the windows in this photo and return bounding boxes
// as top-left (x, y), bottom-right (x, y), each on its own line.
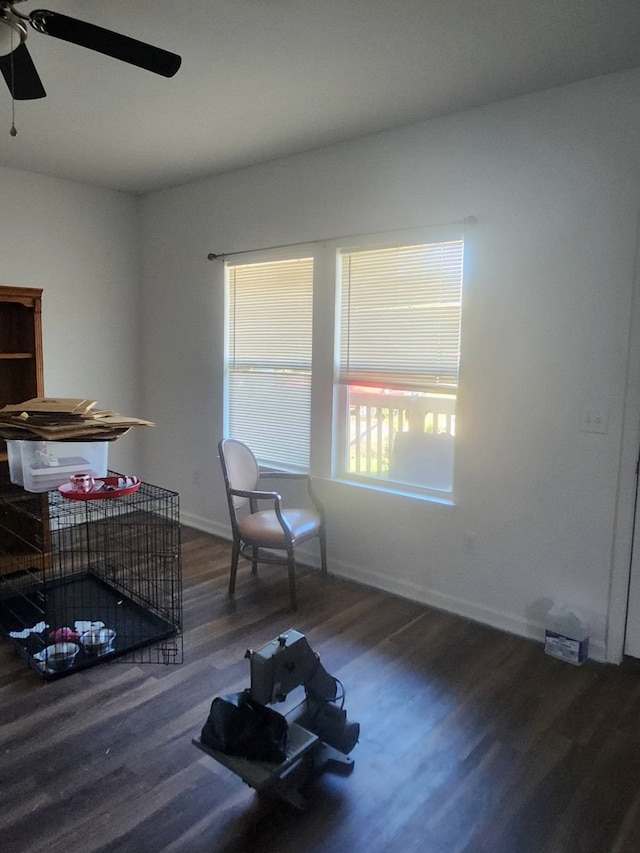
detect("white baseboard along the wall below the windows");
top-left (180, 513), bottom-right (607, 663)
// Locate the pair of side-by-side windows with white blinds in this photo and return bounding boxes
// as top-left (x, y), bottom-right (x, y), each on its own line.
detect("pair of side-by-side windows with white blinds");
top-left (225, 229), bottom-right (464, 499)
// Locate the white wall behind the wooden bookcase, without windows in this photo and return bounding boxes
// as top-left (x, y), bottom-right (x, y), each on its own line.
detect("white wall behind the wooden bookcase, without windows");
top-left (0, 166), bottom-right (144, 471)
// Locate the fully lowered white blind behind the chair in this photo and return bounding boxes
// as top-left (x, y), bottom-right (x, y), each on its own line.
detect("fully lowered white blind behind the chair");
top-left (226, 258), bottom-right (313, 469)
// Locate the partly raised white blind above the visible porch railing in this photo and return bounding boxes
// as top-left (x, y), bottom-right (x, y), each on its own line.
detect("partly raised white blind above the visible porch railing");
top-left (339, 240), bottom-right (464, 393)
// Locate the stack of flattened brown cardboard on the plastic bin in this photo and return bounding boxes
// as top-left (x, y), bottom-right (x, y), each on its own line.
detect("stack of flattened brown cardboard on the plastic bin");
top-left (0, 397), bottom-right (154, 441)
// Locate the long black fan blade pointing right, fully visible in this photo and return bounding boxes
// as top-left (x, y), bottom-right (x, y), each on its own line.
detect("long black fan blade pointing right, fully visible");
top-left (29, 9), bottom-right (182, 77)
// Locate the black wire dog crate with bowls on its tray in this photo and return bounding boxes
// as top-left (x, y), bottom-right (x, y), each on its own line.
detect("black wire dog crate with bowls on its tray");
top-left (0, 472), bottom-right (182, 679)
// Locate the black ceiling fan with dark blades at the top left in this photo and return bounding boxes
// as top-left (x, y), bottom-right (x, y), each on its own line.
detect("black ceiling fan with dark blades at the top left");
top-left (0, 0), bottom-right (182, 101)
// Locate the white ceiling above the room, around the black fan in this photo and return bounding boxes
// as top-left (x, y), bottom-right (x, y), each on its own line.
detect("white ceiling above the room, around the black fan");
top-left (0, 0), bottom-right (640, 193)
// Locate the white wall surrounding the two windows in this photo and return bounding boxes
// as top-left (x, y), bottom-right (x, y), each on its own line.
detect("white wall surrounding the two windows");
top-left (141, 72), bottom-right (640, 658)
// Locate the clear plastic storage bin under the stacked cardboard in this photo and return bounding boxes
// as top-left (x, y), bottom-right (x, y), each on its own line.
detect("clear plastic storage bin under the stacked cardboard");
top-left (7, 440), bottom-right (109, 492)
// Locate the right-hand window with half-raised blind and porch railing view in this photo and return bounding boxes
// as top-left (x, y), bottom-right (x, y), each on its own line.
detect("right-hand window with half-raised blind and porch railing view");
top-left (337, 240), bottom-right (463, 492)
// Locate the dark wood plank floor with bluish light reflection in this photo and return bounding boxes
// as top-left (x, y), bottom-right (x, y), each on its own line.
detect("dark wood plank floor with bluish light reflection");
top-left (0, 530), bottom-right (640, 853)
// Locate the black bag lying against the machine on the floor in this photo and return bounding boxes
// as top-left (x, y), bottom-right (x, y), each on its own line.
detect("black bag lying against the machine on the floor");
top-left (200, 690), bottom-right (289, 763)
